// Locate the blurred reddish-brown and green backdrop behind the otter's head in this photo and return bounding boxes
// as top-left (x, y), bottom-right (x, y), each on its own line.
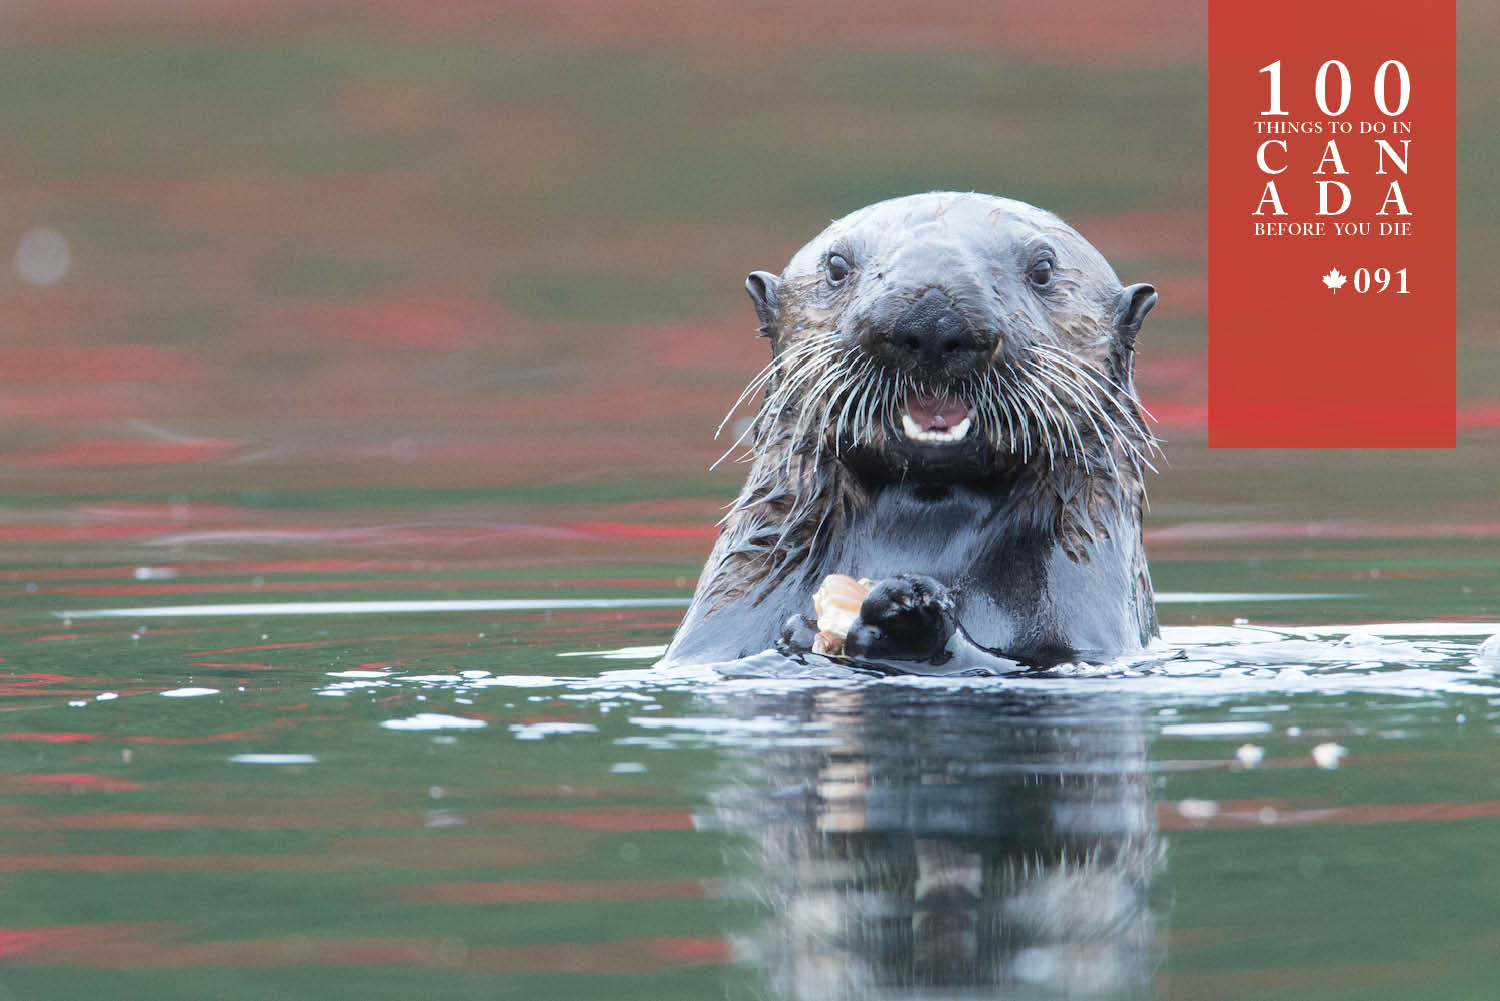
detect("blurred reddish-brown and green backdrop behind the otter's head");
top-left (0, 0), bottom-right (1500, 558)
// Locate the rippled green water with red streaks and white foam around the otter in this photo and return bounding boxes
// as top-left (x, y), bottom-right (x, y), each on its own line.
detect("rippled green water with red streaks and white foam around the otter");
top-left (0, 494), bottom-right (1500, 998)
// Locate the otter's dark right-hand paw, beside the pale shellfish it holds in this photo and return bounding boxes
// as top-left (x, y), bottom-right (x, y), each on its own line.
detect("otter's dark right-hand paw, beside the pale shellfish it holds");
top-left (845, 573), bottom-right (959, 660)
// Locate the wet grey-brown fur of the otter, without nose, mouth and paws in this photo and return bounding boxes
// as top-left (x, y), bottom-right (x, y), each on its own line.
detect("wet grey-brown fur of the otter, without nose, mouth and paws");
top-left (669, 195), bottom-right (1157, 663)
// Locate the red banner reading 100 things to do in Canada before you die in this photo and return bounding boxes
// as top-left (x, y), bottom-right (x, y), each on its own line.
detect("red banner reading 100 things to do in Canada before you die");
top-left (1209, 0), bottom-right (1457, 447)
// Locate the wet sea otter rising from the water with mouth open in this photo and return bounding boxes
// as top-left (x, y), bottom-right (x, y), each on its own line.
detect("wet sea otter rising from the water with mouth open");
top-left (666, 192), bottom-right (1158, 672)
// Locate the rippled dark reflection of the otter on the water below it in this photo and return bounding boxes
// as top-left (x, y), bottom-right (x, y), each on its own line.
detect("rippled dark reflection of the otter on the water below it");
top-left (719, 686), bottom-right (1161, 1001)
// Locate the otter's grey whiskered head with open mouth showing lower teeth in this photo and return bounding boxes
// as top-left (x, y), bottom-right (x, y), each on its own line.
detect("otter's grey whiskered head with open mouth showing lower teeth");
top-left (746, 192), bottom-right (1157, 482)
